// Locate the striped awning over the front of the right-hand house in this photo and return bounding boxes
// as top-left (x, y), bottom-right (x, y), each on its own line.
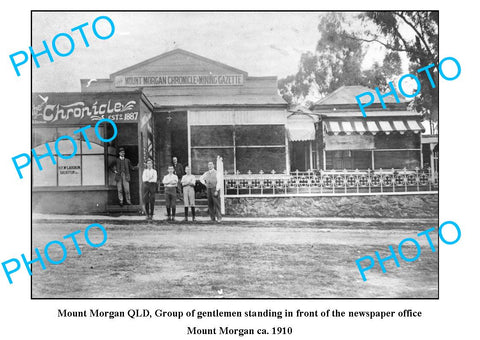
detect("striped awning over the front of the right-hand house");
top-left (324, 119), bottom-right (425, 135)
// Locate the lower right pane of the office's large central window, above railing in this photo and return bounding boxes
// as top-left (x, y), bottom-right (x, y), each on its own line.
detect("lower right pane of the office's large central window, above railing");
top-left (236, 148), bottom-right (286, 174)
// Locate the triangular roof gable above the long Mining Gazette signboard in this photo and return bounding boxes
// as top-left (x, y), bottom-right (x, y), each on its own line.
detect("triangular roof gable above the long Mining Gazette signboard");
top-left (110, 49), bottom-right (248, 79)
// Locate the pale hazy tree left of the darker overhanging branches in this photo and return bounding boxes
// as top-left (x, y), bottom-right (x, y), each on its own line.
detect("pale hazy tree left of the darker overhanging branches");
top-left (278, 13), bottom-right (401, 105)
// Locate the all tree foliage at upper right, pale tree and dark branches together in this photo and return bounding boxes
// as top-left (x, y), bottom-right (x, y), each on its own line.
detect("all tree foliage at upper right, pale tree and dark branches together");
top-left (279, 11), bottom-right (439, 133)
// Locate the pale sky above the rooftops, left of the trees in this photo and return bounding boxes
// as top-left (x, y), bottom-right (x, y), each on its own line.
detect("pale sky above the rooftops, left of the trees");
top-left (32, 12), bottom-right (394, 92)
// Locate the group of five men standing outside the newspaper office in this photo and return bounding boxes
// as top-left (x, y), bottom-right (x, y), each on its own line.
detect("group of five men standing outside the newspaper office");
top-left (112, 148), bottom-right (222, 222)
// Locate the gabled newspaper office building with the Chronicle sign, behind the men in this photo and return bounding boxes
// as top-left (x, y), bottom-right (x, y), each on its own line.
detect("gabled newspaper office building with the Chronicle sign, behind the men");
top-left (32, 49), bottom-right (290, 212)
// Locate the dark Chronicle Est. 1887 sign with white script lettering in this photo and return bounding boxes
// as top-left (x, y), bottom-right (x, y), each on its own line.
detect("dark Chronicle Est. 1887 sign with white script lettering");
top-left (32, 92), bottom-right (140, 124)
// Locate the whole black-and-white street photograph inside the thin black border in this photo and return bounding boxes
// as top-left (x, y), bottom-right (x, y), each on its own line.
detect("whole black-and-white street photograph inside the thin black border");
top-left (30, 10), bottom-right (440, 299)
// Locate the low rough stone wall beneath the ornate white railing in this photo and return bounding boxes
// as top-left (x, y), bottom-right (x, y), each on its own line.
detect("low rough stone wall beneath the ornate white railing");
top-left (225, 194), bottom-right (438, 218)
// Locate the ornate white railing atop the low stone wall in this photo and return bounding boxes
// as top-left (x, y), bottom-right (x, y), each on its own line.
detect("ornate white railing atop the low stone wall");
top-left (224, 169), bottom-right (438, 197)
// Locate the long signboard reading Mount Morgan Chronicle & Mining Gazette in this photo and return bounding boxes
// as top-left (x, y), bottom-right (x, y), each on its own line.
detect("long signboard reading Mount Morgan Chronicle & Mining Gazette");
top-left (115, 74), bottom-right (243, 87)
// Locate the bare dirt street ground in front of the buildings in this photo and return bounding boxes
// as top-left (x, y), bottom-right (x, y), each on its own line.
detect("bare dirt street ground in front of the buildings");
top-left (32, 219), bottom-right (438, 298)
